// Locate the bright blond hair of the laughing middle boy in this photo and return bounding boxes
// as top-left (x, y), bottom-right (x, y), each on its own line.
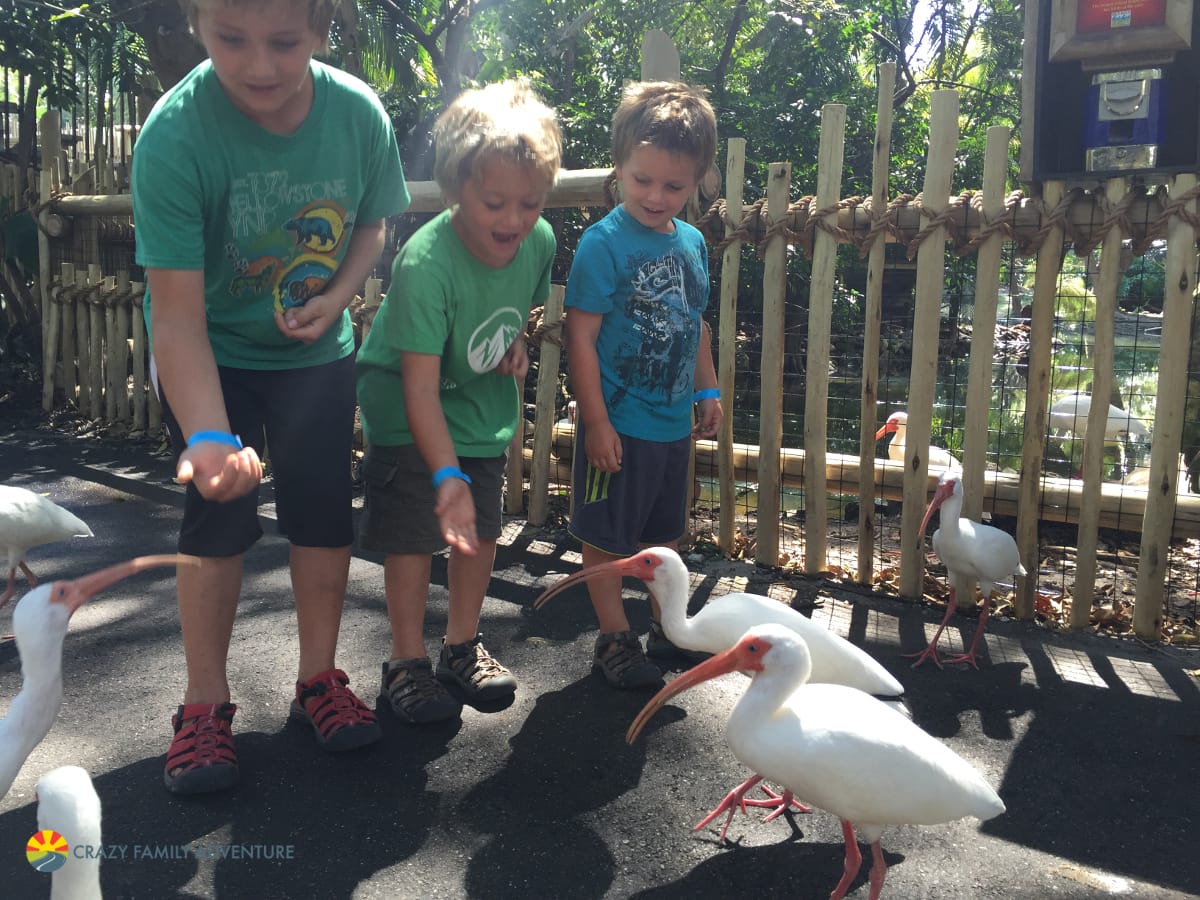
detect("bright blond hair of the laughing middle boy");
top-left (433, 78), bottom-right (563, 200)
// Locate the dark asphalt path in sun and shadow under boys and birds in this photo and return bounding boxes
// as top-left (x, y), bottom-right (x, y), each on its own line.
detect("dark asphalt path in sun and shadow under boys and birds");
top-left (0, 422), bottom-right (1200, 900)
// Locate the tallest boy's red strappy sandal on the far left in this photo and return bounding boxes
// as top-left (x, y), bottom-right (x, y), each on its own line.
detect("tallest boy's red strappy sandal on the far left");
top-left (162, 703), bottom-right (238, 794)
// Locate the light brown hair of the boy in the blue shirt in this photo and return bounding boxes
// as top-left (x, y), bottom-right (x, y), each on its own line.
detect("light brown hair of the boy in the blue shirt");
top-left (612, 82), bottom-right (716, 180)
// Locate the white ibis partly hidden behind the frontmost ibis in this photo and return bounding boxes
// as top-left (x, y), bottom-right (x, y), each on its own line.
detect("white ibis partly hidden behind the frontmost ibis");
top-left (534, 547), bottom-right (907, 838)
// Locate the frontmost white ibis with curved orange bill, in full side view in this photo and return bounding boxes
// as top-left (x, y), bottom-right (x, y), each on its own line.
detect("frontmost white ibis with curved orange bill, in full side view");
top-left (625, 625), bottom-right (1004, 900)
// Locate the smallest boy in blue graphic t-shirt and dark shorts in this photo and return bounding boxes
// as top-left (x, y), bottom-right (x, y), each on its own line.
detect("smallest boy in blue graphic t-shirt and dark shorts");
top-left (566, 82), bottom-right (721, 689)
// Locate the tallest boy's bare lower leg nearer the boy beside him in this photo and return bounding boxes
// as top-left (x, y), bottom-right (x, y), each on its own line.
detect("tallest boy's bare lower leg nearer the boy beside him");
top-left (290, 545), bottom-right (350, 682)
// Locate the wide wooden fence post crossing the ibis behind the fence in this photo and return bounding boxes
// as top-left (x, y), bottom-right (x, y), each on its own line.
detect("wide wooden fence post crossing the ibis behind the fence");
top-left (900, 90), bottom-right (955, 602)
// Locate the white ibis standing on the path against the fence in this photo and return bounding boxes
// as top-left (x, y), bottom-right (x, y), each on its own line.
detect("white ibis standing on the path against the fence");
top-left (907, 472), bottom-right (1026, 668)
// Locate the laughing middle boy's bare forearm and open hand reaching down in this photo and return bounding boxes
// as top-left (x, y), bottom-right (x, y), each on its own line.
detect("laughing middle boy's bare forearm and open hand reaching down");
top-left (400, 352), bottom-right (479, 556)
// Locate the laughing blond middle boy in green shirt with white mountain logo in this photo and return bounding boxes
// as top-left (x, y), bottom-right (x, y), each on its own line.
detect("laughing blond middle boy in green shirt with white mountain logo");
top-left (358, 80), bottom-right (562, 722)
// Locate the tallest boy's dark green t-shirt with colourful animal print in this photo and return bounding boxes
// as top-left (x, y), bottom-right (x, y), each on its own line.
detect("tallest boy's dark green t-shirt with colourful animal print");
top-left (133, 60), bottom-right (409, 370)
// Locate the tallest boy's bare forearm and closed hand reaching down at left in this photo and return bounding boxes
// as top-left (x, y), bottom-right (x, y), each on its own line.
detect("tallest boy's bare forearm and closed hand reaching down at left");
top-left (146, 269), bottom-right (262, 502)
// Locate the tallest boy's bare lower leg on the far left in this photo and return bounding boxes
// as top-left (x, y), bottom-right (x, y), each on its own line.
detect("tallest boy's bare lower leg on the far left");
top-left (175, 554), bottom-right (242, 703)
